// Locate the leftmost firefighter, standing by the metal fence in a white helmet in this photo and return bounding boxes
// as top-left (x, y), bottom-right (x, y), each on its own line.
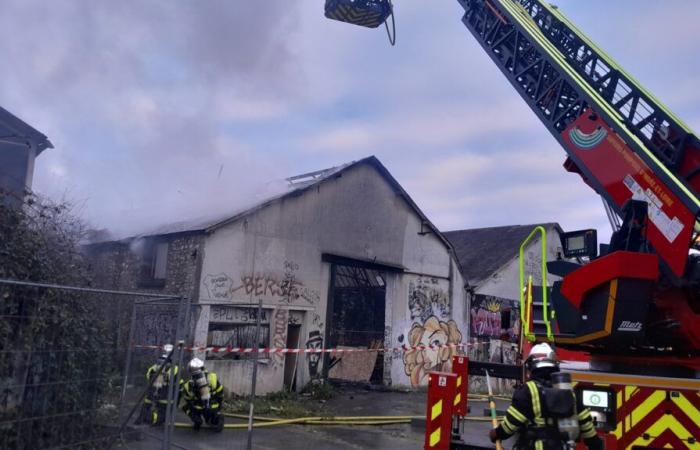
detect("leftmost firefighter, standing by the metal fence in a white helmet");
top-left (141, 344), bottom-right (178, 426)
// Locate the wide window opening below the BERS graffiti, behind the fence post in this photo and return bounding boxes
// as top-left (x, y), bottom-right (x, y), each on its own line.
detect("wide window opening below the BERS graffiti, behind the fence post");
top-left (207, 306), bottom-right (270, 360)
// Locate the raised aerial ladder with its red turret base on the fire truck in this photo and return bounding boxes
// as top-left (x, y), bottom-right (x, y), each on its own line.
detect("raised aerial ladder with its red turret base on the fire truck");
top-left (459, 0), bottom-right (700, 362)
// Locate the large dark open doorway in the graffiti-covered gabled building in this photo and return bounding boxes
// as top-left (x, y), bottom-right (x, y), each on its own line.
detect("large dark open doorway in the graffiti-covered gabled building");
top-left (325, 263), bottom-right (386, 383)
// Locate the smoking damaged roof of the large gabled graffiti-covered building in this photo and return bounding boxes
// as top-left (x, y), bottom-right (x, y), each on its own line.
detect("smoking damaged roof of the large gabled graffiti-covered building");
top-left (92, 156), bottom-right (451, 249)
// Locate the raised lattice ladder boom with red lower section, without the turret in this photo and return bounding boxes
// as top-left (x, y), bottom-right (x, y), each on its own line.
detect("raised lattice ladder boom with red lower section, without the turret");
top-left (458, 0), bottom-right (700, 277)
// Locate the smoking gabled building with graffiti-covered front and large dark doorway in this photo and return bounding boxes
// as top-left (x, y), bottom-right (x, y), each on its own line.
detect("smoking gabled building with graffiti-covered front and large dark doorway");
top-left (89, 157), bottom-right (469, 393)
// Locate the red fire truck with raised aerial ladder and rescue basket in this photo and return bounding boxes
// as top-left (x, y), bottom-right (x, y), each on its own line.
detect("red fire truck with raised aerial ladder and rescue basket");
top-left (325, 0), bottom-right (700, 449)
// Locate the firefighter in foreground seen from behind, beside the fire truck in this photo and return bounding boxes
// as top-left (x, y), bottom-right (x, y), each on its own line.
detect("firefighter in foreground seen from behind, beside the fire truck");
top-left (489, 343), bottom-right (603, 450)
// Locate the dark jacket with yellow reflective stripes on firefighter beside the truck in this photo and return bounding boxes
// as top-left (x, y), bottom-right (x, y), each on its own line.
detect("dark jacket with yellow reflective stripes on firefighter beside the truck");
top-left (496, 380), bottom-right (603, 450)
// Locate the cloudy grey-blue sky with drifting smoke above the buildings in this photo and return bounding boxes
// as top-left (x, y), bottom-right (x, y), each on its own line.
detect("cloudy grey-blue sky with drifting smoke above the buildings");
top-left (0, 0), bottom-right (700, 243)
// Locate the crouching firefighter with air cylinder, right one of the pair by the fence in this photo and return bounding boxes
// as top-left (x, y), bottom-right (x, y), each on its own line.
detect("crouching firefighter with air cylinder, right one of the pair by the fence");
top-left (182, 358), bottom-right (224, 431)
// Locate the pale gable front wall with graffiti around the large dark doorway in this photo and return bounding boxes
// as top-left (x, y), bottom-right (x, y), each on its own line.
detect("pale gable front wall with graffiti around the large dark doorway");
top-left (195, 164), bottom-right (468, 393)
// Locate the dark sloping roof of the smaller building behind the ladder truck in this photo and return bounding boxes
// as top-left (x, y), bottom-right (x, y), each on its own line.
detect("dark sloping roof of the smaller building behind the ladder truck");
top-left (442, 222), bottom-right (561, 286)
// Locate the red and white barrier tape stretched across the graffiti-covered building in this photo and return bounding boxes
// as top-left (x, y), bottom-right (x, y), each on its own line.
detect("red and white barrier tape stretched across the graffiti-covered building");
top-left (134, 343), bottom-right (475, 354)
